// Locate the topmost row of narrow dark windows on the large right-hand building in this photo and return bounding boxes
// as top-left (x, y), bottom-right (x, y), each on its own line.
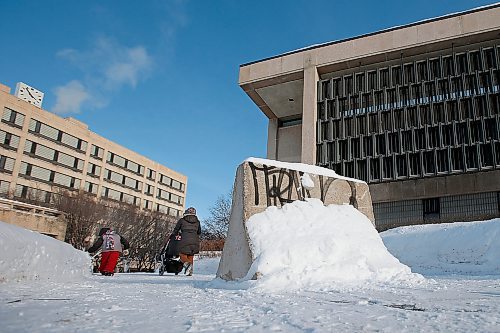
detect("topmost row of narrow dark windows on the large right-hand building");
top-left (319, 46), bottom-right (500, 99)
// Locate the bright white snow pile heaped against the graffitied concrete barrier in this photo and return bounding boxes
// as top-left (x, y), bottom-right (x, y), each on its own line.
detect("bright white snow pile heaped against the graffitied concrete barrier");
top-left (243, 199), bottom-right (425, 291)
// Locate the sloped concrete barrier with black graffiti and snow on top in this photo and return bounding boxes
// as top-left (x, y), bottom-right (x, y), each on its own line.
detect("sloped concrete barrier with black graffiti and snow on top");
top-left (217, 158), bottom-right (375, 280)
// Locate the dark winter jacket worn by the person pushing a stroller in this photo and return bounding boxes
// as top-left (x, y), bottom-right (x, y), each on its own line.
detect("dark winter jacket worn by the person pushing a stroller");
top-left (172, 215), bottom-right (201, 255)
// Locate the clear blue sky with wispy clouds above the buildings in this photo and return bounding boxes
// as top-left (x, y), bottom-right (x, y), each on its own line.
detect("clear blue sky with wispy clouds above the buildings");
top-left (0, 0), bottom-right (495, 219)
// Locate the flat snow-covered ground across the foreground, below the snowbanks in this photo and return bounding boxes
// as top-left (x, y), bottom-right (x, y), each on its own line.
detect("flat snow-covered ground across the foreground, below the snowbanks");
top-left (0, 259), bottom-right (500, 333)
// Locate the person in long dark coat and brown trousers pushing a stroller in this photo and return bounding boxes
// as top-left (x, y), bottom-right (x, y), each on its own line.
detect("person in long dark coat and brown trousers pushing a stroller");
top-left (170, 207), bottom-right (201, 276)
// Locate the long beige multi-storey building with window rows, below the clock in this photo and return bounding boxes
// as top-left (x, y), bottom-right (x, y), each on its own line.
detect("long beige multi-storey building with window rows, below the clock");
top-left (0, 84), bottom-right (187, 217)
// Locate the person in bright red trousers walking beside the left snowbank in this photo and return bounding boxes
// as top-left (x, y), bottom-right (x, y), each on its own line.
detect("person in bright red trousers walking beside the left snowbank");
top-left (87, 228), bottom-right (130, 276)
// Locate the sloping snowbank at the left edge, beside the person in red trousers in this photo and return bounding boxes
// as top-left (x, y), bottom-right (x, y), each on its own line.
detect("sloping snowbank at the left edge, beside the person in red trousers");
top-left (0, 222), bottom-right (91, 283)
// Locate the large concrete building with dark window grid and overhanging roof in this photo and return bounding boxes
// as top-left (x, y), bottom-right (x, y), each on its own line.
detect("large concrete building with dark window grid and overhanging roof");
top-left (239, 4), bottom-right (500, 230)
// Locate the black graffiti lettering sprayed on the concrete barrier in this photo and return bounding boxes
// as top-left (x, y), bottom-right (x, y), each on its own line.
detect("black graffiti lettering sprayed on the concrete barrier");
top-left (249, 162), bottom-right (358, 208)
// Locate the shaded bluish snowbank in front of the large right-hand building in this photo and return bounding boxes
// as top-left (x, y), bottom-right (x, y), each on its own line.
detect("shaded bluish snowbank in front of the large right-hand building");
top-left (381, 218), bottom-right (500, 275)
